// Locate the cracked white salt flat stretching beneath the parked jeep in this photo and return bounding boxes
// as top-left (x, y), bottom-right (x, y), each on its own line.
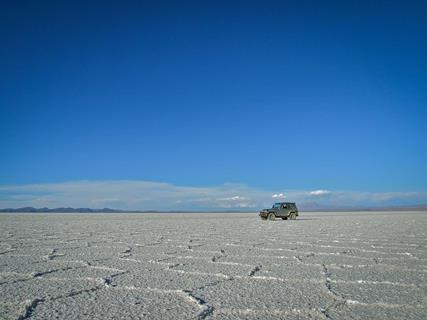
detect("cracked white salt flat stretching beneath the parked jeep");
top-left (0, 212), bottom-right (427, 319)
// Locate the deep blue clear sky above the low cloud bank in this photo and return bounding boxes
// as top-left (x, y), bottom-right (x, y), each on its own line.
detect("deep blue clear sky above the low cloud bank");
top-left (0, 1), bottom-right (427, 209)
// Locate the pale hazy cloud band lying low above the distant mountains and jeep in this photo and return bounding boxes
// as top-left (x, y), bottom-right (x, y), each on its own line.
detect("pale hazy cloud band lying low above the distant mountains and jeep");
top-left (0, 180), bottom-right (427, 211)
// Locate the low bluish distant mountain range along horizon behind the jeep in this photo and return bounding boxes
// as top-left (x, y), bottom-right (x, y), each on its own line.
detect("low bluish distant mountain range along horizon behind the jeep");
top-left (0, 203), bottom-right (427, 213)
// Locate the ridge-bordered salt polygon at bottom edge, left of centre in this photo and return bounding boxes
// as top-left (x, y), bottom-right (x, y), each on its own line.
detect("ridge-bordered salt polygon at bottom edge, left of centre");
top-left (32, 287), bottom-right (201, 320)
